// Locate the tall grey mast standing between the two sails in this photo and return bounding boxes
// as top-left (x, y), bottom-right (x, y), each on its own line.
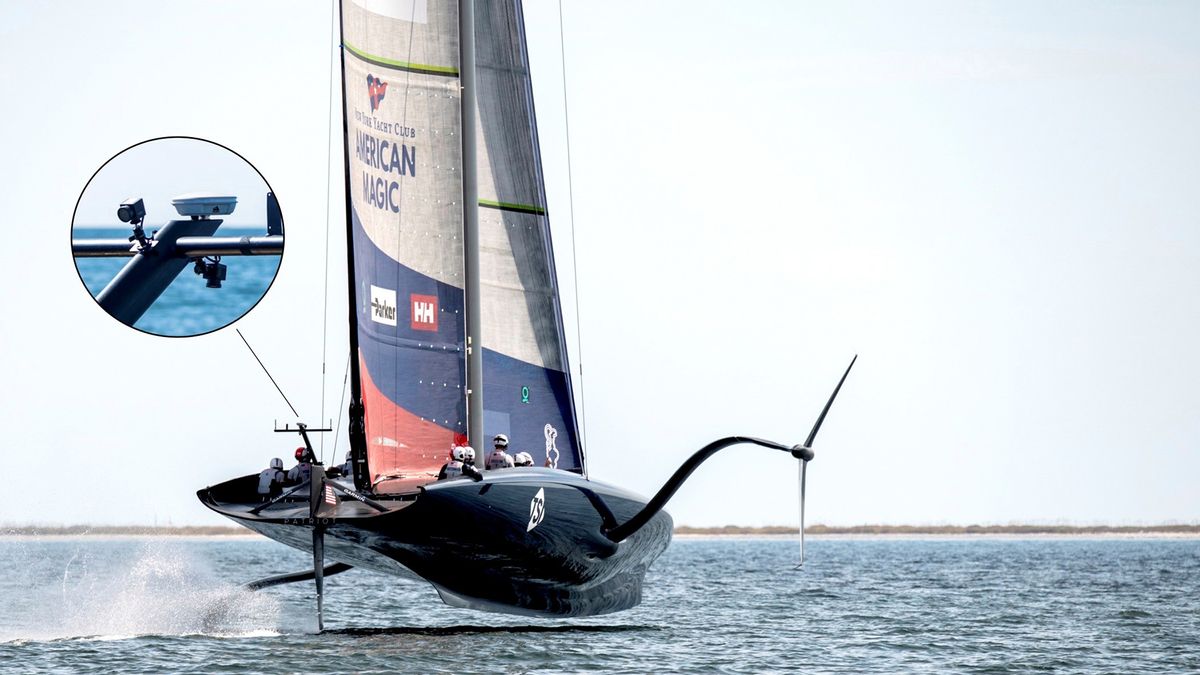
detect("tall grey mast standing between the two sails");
top-left (458, 0), bottom-right (484, 453)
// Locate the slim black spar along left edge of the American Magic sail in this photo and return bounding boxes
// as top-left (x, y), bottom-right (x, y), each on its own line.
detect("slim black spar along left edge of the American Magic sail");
top-left (337, 1), bottom-right (371, 490)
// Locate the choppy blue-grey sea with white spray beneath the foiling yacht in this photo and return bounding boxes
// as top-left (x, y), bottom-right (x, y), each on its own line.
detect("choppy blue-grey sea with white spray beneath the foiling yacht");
top-left (0, 538), bottom-right (1200, 674)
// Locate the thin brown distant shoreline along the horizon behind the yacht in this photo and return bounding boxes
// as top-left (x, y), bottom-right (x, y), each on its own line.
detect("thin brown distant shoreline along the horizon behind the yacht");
top-left (0, 525), bottom-right (1200, 539)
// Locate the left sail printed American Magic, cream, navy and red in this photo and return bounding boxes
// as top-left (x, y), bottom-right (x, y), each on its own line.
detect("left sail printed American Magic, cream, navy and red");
top-left (342, 0), bottom-right (467, 491)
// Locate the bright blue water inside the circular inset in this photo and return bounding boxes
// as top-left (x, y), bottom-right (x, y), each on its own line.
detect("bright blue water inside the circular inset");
top-left (74, 226), bottom-right (281, 336)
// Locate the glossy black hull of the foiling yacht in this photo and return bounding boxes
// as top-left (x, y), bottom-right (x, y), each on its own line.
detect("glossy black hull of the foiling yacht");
top-left (198, 468), bottom-right (672, 616)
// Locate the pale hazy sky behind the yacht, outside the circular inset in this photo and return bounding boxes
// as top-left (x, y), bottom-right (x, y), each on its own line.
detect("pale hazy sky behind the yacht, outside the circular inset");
top-left (0, 0), bottom-right (1200, 525)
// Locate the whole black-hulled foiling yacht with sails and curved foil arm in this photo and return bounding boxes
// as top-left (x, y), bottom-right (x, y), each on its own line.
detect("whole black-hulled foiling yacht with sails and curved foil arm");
top-left (198, 0), bottom-right (853, 621)
